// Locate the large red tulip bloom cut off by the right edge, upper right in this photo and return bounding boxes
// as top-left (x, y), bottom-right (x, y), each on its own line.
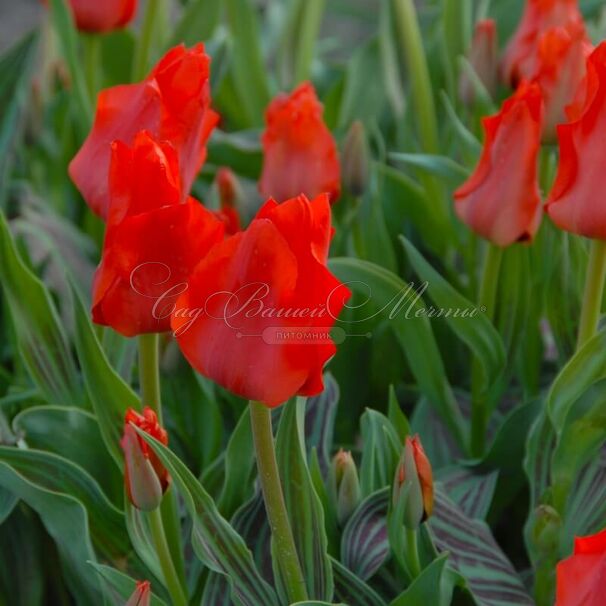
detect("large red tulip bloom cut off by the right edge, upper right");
top-left (547, 43), bottom-right (606, 240)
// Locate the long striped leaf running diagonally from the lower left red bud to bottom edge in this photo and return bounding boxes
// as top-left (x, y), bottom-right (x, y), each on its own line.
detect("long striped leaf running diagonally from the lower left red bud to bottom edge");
top-left (136, 428), bottom-right (278, 606)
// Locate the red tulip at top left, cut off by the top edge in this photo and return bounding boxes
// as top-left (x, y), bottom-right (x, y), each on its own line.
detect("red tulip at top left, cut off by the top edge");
top-left (42, 0), bottom-right (137, 33)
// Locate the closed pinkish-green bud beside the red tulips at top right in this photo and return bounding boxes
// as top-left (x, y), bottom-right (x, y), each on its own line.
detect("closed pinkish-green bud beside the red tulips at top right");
top-left (459, 19), bottom-right (499, 105)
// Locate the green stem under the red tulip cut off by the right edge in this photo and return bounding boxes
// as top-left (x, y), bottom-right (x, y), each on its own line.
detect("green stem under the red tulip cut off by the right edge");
top-left (577, 240), bottom-right (606, 349)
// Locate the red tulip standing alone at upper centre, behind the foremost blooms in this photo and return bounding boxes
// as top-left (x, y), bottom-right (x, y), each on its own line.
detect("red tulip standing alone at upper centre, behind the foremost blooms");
top-left (259, 82), bottom-right (341, 202)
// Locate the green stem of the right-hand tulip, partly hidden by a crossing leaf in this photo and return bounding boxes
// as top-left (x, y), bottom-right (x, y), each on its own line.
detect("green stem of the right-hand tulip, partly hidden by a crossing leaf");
top-left (471, 244), bottom-right (503, 457)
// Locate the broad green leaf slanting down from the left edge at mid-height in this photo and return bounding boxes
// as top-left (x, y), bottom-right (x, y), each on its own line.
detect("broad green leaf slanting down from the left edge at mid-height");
top-left (0, 213), bottom-right (84, 405)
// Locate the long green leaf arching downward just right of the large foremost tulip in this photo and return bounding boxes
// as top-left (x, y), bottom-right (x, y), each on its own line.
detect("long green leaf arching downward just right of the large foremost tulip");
top-left (329, 258), bottom-right (466, 446)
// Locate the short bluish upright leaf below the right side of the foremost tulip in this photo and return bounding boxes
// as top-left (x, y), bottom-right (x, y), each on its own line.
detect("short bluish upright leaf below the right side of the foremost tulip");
top-left (305, 373), bottom-right (339, 477)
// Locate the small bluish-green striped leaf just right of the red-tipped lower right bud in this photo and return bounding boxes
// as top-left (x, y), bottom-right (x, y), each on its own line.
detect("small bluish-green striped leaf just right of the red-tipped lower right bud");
top-left (436, 465), bottom-right (499, 520)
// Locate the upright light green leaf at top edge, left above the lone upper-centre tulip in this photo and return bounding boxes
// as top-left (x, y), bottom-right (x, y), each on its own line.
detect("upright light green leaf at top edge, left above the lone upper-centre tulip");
top-left (225, 0), bottom-right (270, 126)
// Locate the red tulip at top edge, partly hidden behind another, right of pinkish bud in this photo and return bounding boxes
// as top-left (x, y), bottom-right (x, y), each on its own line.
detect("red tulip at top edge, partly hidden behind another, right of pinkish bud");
top-left (501, 0), bottom-right (586, 87)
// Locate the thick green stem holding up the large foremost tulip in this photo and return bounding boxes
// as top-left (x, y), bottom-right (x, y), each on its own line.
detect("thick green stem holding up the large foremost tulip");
top-left (250, 401), bottom-right (307, 603)
